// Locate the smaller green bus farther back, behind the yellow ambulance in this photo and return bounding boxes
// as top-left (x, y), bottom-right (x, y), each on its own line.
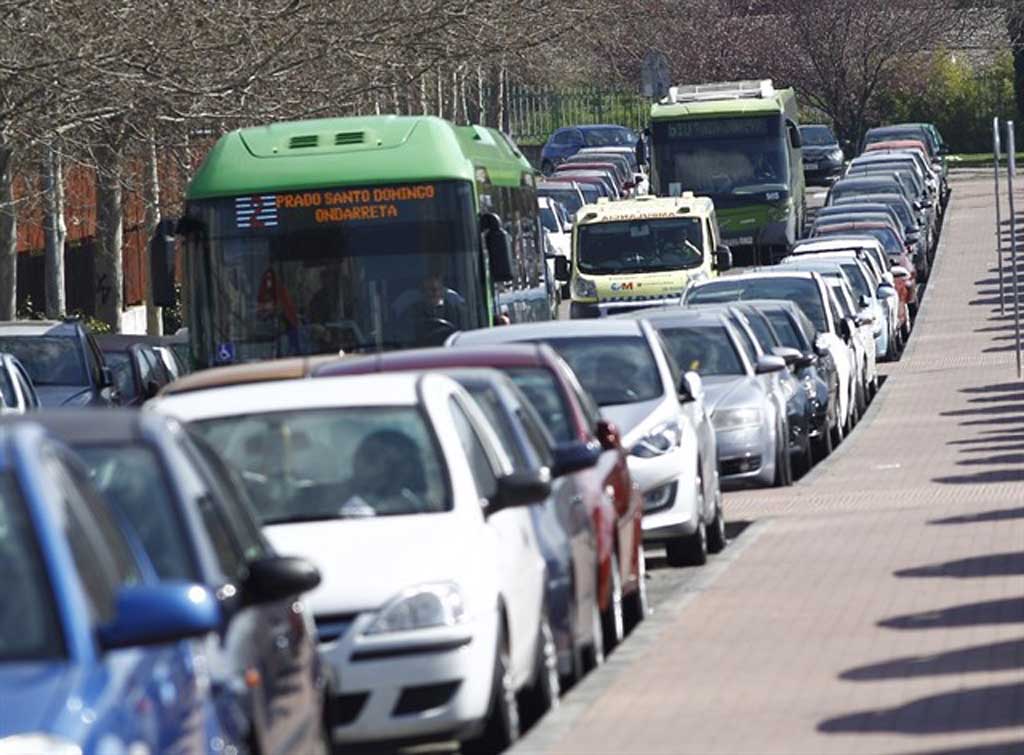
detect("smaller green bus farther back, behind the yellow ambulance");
top-left (650, 80), bottom-right (806, 263)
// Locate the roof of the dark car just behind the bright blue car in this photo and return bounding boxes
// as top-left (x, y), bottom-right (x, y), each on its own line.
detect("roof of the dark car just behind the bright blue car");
top-left (2, 409), bottom-right (161, 446)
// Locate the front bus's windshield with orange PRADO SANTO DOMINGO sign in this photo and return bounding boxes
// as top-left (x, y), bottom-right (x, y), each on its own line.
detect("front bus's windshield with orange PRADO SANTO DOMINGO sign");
top-left (186, 181), bottom-right (487, 365)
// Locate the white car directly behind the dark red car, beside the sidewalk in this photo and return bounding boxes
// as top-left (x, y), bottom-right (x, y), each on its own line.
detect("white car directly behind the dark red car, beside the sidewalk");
top-left (449, 318), bottom-right (726, 565)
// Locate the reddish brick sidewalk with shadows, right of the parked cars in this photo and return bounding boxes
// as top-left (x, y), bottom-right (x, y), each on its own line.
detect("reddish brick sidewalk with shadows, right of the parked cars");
top-left (516, 174), bottom-right (1024, 755)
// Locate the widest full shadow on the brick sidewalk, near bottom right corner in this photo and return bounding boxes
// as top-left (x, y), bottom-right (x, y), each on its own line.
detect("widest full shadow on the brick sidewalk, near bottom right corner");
top-left (818, 682), bottom-right (1024, 735)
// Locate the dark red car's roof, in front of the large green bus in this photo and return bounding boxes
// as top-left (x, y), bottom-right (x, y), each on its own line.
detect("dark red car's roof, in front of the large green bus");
top-left (313, 342), bottom-right (555, 378)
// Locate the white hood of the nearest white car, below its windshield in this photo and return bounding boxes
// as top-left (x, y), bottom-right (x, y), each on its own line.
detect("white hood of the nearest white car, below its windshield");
top-left (263, 512), bottom-right (487, 616)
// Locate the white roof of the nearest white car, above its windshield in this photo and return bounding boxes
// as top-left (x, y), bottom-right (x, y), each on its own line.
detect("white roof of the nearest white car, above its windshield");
top-left (153, 373), bottom-right (434, 422)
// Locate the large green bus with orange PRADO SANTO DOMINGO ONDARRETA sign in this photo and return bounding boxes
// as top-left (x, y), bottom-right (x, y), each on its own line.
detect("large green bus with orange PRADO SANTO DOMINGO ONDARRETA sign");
top-left (177, 116), bottom-right (553, 368)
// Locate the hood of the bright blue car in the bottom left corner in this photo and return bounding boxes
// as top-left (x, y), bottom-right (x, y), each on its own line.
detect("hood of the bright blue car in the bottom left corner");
top-left (0, 661), bottom-right (81, 739)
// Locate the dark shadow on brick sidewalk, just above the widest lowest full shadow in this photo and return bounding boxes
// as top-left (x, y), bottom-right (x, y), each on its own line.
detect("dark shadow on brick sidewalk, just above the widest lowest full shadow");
top-left (840, 639), bottom-right (1024, 681)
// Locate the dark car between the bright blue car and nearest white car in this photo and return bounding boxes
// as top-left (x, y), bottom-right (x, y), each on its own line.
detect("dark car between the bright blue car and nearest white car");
top-left (12, 409), bottom-right (326, 755)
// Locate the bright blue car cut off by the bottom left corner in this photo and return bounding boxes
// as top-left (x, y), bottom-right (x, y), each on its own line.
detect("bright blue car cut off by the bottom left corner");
top-left (0, 422), bottom-right (224, 755)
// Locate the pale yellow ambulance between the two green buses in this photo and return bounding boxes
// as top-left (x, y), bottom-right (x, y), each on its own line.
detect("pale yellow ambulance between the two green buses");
top-left (556, 193), bottom-right (732, 320)
